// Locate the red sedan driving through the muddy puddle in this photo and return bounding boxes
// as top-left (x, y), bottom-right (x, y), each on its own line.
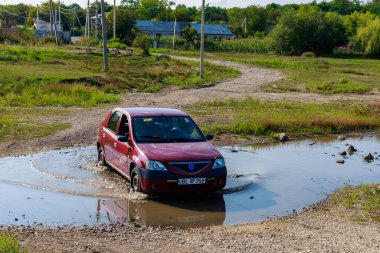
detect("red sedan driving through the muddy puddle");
top-left (97, 108), bottom-right (227, 193)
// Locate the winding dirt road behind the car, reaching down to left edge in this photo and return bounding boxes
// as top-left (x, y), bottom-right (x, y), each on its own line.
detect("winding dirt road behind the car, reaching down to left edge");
top-left (0, 57), bottom-right (380, 157)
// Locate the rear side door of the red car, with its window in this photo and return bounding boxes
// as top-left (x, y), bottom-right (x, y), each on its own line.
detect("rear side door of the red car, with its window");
top-left (104, 111), bottom-right (121, 169)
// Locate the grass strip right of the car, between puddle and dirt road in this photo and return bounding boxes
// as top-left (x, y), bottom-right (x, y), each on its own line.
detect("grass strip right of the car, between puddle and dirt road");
top-left (185, 98), bottom-right (380, 136)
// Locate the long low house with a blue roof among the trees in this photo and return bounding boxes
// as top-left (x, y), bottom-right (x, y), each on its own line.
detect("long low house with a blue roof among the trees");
top-left (136, 20), bottom-right (235, 39)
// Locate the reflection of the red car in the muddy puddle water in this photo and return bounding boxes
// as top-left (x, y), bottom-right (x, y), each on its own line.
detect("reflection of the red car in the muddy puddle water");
top-left (101, 195), bottom-right (226, 228)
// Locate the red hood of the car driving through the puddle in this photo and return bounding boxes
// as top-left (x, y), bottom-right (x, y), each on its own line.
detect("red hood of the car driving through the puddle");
top-left (138, 141), bottom-right (222, 162)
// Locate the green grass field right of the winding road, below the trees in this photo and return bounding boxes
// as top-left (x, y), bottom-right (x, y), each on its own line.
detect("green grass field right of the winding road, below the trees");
top-left (155, 50), bottom-right (380, 94)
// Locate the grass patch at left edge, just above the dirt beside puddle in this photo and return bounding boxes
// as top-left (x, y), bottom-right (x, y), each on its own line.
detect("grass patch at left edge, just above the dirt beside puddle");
top-left (0, 107), bottom-right (70, 142)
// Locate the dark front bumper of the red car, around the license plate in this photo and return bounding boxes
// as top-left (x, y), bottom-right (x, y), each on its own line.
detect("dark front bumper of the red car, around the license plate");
top-left (139, 167), bottom-right (227, 193)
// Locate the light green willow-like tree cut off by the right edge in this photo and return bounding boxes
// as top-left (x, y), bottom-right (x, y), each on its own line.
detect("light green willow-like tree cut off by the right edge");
top-left (357, 18), bottom-right (380, 57)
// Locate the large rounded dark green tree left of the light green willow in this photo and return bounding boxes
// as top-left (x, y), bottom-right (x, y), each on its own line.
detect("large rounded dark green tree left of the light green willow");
top-left (270, 5), bottom-right (346, 54)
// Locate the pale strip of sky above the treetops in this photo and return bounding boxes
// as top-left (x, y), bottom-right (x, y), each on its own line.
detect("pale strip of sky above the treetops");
top-left (0, 0), bottom-right (326, 7)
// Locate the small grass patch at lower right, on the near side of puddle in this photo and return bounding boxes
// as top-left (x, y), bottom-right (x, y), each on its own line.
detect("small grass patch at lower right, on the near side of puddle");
top-left (331, 184), bottom-right (380, 222)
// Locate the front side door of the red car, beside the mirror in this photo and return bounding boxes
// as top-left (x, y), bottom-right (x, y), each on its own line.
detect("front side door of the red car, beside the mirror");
top-left (114, 114), bottom-right (132, 177)
